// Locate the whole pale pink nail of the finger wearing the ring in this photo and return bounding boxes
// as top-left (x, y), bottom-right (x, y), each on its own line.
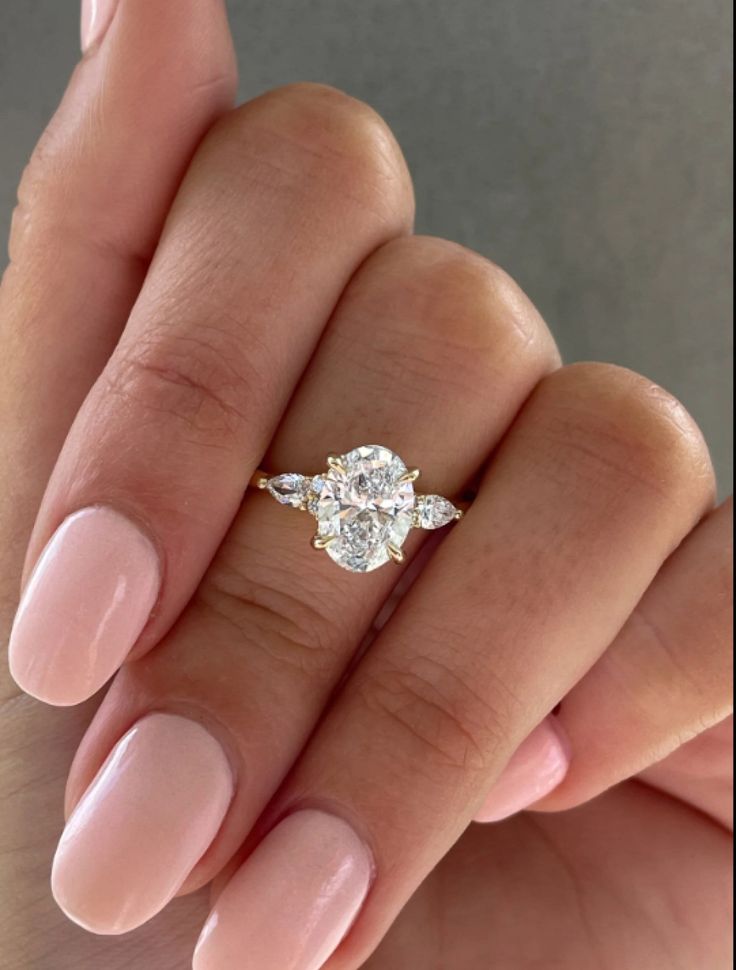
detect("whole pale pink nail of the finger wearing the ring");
top-left (51, 714), bottom-right (233, 934)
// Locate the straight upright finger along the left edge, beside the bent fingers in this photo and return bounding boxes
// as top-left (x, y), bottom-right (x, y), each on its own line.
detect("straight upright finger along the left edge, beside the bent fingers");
top-left (0, 0), bottom-right (236, 680)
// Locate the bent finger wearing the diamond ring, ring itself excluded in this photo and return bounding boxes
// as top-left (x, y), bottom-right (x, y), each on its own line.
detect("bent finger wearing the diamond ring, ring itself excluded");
top-left (56, 231), bottom-right (556, 928)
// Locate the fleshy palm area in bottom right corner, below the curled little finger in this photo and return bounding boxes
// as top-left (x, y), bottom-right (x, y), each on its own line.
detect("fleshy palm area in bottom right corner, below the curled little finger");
top-left (366, 784), bottom-right (733, 970)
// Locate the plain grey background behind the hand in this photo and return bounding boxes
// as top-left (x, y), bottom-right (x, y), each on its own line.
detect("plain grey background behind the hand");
top-left (0, 0), bottom-right (732, 484)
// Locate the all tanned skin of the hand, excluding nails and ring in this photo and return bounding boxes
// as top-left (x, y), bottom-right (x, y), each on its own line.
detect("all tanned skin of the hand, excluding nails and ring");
top-left (0, 0), bottom-right (731, 970)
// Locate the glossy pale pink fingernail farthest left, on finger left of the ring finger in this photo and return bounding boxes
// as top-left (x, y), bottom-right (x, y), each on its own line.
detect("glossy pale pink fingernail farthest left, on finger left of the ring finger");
top-left (10, 506), bottom-right (160, 706)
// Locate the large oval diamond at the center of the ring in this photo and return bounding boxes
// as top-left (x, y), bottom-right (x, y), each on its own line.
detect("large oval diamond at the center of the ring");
top-left (313, 445), bottom-right (414, 573)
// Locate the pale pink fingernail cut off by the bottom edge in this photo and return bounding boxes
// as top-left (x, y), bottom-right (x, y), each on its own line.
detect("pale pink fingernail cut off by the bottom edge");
top-left (194, 810), bottom-right (373, 970)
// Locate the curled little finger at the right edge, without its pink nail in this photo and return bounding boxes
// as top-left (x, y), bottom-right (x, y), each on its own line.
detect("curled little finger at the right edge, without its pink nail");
top-left (528, 501), bottom-right (733, 815)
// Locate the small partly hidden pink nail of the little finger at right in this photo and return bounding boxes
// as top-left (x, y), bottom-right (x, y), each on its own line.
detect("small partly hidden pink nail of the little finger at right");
top-left (475, 717), bottom-right (570, 822)
